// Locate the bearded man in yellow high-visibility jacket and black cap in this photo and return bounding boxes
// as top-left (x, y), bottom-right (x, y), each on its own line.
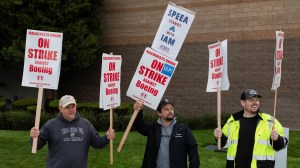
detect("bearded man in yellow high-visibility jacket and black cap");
top-left (214, 89), bottom-right (288, 168)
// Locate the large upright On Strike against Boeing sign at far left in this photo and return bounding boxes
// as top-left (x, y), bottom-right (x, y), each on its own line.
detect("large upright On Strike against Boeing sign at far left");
top-left (22, 29), bottom-right (63, 89)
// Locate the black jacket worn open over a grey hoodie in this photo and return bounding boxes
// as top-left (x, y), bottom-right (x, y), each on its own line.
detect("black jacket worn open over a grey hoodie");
top-left (133, 112), bottom-right (200, 168)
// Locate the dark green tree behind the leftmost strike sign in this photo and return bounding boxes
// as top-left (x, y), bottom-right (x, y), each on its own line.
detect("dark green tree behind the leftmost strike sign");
top-left (0, 0), bottom-right (102, 69)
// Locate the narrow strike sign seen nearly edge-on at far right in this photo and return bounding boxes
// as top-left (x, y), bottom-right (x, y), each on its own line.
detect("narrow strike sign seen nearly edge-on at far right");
top-left (272, 31), bottom-right (284, 90)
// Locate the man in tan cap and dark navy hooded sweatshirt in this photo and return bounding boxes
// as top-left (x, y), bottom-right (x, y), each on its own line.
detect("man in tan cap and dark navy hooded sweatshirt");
top-left (30, 95), bottom-right (115, 168)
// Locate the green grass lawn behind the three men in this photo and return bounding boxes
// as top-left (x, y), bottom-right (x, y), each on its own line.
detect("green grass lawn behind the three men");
top-left (0, 130), bottom-right (300, 168)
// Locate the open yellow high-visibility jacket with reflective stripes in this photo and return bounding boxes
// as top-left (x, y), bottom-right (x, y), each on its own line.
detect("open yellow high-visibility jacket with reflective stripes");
top-left (222, 110), bottom-right (288, 168)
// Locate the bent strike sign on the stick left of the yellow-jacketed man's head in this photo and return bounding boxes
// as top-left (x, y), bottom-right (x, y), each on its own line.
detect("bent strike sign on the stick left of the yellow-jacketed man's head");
top-left (206, 39), bottom-right (230, 92)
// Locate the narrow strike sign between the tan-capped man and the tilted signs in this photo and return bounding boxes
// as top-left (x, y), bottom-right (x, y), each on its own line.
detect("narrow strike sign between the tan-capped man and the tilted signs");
top-left (99, 53), bottom-right (122, 110)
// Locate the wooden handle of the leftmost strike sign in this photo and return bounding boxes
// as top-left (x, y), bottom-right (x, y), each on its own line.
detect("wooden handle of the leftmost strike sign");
top-left (31, 88), bottom-right (43, 154)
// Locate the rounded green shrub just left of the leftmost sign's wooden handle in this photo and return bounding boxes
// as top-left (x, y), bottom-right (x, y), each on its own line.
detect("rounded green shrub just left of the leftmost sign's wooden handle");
top-left (11, 111), bottom-right (35, 130)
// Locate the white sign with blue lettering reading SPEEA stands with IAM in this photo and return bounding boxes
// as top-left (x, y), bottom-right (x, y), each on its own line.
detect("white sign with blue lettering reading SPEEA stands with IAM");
top-left (151, 3), bottom-right (195, 60)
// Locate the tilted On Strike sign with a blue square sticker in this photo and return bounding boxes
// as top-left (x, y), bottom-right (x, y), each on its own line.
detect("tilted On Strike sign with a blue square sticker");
top-left (126, 47), bottom-right (178, 110)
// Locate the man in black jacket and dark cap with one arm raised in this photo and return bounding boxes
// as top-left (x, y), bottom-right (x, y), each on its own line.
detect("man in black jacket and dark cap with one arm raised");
top-left (133, 99), bottom-right (200, 168)
